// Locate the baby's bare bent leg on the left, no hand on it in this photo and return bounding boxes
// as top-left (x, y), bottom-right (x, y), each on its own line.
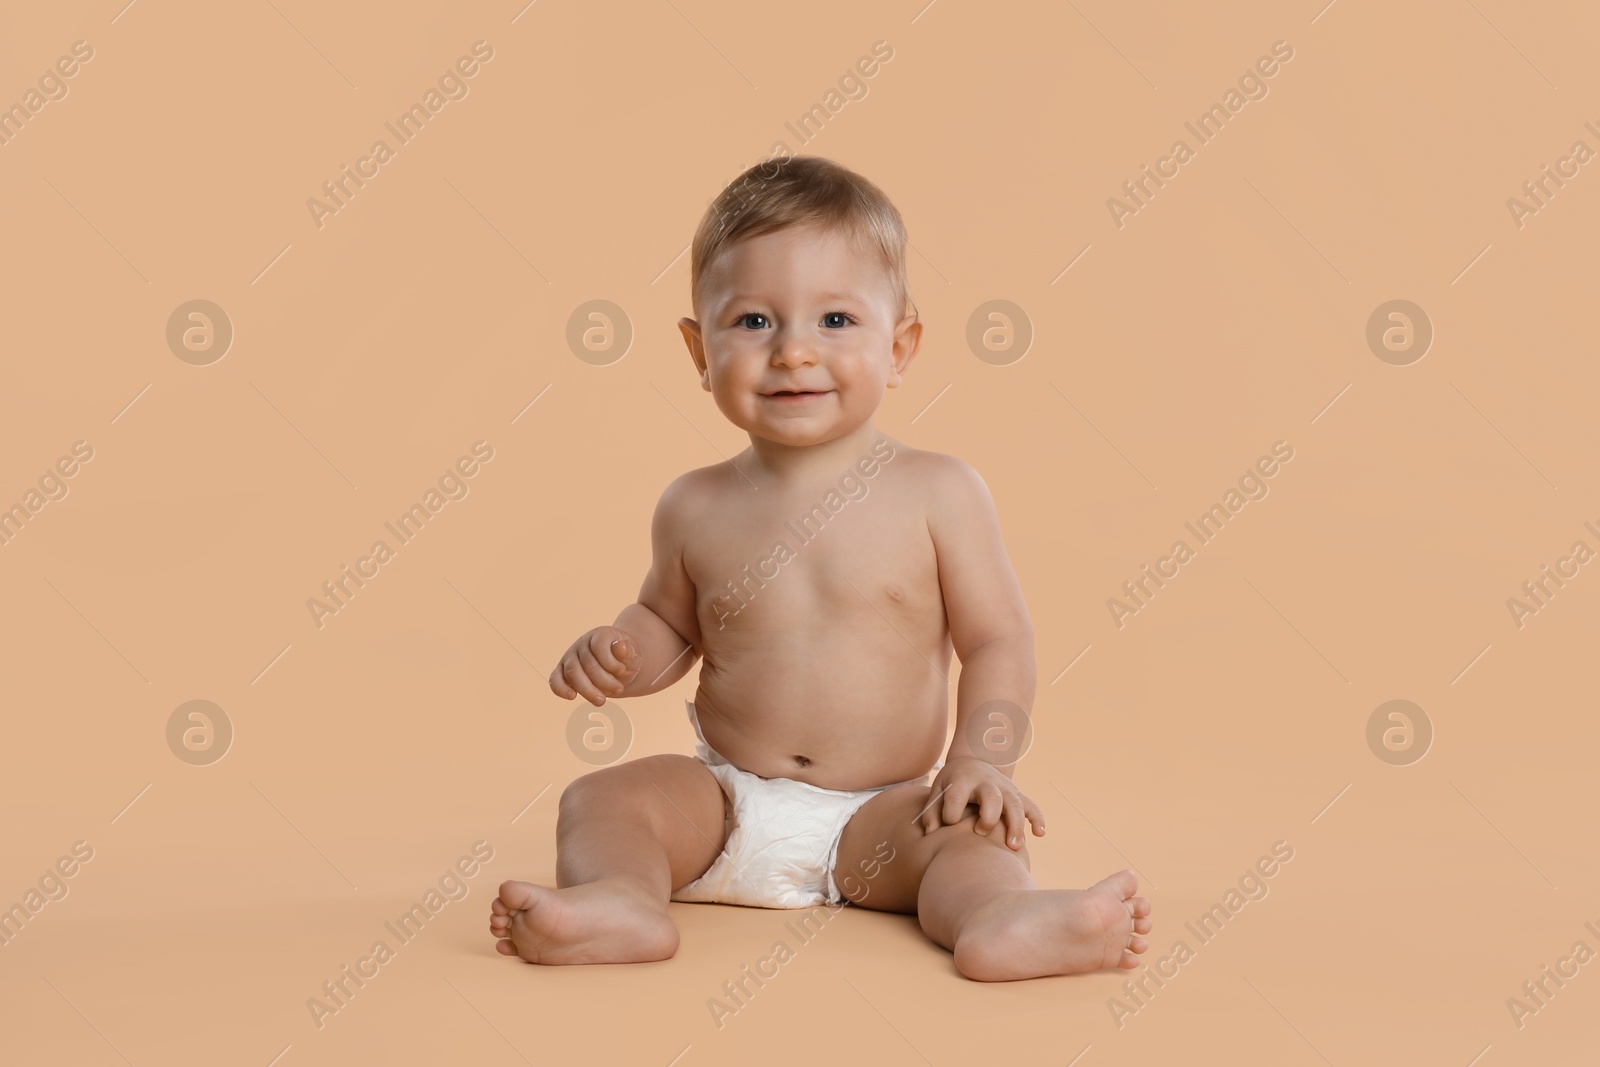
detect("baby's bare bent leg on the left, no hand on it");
top-left (490, 755), bottom-right (723, 963)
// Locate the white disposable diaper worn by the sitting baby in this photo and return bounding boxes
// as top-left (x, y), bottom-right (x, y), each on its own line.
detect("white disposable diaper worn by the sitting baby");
top-left (672, 701), bottom-right (942, 909)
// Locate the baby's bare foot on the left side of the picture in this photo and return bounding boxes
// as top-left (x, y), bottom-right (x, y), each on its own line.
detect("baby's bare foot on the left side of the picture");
top-left (490, 880), bottom-right (678, 963)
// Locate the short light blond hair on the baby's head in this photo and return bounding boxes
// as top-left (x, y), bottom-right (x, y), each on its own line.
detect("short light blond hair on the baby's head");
top-left (690, 155), bottom-right (917, 315)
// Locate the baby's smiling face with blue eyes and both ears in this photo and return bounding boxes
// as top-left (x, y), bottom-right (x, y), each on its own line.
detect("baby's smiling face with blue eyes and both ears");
top-left (678, 226), bottom-right (922, 445)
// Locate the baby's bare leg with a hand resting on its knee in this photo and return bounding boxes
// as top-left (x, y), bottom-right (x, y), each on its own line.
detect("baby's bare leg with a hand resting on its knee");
top-left (834, 785), bottom-right (1150, 982)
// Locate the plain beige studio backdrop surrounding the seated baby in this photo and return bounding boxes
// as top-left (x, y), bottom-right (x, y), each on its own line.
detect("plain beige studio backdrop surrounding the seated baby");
top-left (0, 0), bottom-right (1600, 1067)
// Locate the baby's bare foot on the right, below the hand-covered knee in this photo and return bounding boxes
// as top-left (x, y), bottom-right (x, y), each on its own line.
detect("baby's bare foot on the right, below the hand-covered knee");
top-left (955, 870), bottom-right (1150, 982)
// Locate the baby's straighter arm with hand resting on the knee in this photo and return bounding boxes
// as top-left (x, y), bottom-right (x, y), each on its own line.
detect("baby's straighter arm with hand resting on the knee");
top-left (923, 456), bottom-right (1045, 848)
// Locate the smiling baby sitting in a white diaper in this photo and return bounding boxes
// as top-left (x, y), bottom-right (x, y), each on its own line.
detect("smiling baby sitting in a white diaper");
top-left (490, 157), bottom-right (1150, 981)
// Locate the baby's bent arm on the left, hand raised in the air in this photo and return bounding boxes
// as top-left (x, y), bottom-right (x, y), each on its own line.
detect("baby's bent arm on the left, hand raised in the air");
top-left (550, 478), bottom-right (699, 707)
